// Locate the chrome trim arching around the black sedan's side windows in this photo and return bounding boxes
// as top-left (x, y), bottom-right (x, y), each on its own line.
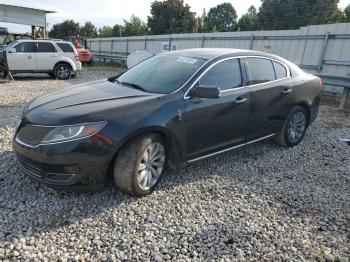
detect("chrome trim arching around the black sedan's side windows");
top-left (184, 55), bottom-right (291, 99)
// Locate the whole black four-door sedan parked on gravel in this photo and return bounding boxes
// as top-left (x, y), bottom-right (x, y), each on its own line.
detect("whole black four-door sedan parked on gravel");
top-left (13, 49), bottom-right (322, 197)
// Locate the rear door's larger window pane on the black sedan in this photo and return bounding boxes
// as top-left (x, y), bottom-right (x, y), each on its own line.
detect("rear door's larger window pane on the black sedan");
top-left (246, 57), bottom-right (276, 85)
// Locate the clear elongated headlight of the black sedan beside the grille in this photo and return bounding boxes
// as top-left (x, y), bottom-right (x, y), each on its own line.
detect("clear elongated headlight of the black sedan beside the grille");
top-left (41, 122), bottom-right (106, 144)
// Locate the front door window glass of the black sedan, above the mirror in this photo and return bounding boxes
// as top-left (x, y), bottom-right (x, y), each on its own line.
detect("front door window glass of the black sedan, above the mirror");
top-left (199, 59), bottom-right (242, 91)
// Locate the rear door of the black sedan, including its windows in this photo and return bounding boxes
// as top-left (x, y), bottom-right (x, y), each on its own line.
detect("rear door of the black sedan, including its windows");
top-left (245, 57), bottom-right (293, 140)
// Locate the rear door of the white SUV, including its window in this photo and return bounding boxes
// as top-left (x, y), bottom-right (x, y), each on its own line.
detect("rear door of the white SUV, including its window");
top-left (37, 41), bottom-right (59, 71)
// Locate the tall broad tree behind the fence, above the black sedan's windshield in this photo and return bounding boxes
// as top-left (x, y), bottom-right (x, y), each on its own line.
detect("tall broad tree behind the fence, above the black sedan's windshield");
top-left (147, 0), bottom-right (196, 34)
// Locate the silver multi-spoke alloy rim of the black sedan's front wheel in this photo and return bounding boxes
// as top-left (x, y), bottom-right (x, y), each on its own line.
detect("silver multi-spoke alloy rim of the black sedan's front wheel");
top-left (137, 142), bottom-right (165, 190)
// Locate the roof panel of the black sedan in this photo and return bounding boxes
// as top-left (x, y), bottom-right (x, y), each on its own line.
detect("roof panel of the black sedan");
top-left (164, 48), bottom-right (275, 60)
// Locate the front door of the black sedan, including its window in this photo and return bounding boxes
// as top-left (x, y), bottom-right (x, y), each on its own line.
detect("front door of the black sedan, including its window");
top-left (185, 59), bottom-right (250, 159)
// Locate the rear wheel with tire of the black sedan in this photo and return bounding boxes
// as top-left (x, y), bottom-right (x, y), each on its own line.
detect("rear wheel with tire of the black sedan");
top-left (274, 106), bottom-right (309, 147)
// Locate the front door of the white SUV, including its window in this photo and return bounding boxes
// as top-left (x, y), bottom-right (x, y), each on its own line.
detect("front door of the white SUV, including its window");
top-left (7, 42), bottom-right (37, 71)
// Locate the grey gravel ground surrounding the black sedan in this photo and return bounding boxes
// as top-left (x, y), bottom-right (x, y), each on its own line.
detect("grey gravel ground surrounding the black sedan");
top-left (0, 68), bottom-right (350, 262)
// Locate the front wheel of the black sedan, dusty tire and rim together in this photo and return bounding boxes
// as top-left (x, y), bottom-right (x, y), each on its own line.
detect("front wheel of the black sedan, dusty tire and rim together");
top-left (114, 133), bottom-right (167, 197)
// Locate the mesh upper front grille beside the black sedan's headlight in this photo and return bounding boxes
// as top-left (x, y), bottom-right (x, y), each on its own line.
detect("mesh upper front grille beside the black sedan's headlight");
top-left (17, 125), bottom-right (54, 146)
